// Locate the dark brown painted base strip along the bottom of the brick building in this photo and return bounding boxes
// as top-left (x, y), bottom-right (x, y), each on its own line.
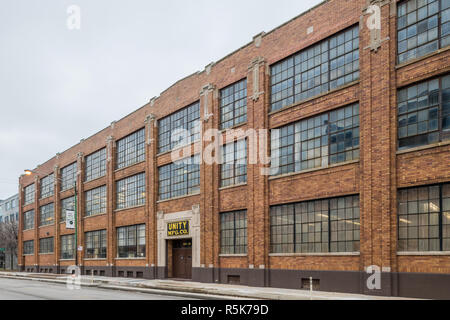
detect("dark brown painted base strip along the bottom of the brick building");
top-left (21, 266), bottom-right (450, 300)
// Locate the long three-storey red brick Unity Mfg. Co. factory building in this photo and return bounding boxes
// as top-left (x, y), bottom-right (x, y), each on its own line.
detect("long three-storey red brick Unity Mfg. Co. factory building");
top-left (19, 0), bottom-right (450, 298)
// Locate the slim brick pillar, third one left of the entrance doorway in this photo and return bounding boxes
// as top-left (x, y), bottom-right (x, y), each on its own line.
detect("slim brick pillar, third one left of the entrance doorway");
top-left (76, 152), bottom-right (86, 273)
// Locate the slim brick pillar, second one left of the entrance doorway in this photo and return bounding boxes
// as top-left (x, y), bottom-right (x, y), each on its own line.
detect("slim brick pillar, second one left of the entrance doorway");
top-left (106, 136), bottom-right (116, 277)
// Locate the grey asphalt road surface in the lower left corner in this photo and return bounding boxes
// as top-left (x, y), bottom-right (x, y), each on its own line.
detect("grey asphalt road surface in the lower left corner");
top-left (0, 278), bottom-right (197, 300)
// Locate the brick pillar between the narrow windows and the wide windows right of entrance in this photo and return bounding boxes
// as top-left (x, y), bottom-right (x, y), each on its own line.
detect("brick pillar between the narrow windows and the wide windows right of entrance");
top-left (247, 57), bottom-right (268, 287)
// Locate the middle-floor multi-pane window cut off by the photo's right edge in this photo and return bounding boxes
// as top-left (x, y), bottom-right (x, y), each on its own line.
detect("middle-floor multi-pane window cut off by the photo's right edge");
top-left (398, 75), bottom-right (450, 149)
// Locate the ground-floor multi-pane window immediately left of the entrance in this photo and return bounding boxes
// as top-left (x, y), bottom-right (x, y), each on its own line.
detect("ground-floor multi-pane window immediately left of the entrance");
top-left (117, 224), bottom-right (145, 258)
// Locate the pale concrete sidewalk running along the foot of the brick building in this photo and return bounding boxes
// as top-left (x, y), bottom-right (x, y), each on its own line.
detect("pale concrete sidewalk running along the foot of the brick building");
top-left (0, 272), bottom-right (414, 300)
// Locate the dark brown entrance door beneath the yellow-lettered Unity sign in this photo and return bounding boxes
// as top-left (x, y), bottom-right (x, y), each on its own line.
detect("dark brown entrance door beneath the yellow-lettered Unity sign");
top-left (172, 239), bottom-right (192, 279)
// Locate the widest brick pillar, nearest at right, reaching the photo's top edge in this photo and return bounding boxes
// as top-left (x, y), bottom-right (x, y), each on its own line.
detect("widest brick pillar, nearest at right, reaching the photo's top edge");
top-left (360, 1), bottom-right (395, 295)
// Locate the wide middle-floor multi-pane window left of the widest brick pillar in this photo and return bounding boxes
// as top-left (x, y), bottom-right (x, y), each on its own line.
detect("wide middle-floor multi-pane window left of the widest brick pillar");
top-left (271, 104), bottom-right (360, 175)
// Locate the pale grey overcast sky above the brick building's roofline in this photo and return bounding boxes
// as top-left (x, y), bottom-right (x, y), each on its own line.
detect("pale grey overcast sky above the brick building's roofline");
top-left (0, 0), bottom-right (322, 199)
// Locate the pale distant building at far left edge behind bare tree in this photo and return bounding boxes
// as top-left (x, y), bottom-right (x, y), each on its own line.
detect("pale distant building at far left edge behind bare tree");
top-left (0, 194), bottom-right (19, 269)
